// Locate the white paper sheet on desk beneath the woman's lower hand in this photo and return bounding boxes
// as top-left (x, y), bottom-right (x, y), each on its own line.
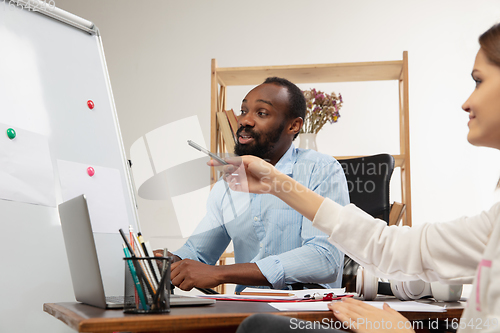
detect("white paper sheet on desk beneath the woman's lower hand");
top-left (269, 301), bottom-right (446, 312)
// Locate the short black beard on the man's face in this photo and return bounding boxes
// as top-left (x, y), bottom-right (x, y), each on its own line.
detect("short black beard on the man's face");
top-left (234, 121), bottom-right (286, 159)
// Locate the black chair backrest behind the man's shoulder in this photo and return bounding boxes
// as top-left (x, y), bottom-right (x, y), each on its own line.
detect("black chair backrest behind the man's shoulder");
top-left (339, 154), bottom-right (394, 223)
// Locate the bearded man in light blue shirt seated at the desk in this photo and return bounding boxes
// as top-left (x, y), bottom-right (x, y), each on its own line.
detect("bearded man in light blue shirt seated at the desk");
top-left (171, 78), bottom-right (349, 291)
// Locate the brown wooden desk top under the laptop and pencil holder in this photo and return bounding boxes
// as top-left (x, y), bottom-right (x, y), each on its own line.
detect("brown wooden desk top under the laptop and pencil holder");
top-left (43, 298), bottom-right (465, 333)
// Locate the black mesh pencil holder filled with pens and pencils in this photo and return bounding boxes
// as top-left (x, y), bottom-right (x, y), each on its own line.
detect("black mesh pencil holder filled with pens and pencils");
top-left (123, 257), bottom-right (171, 313)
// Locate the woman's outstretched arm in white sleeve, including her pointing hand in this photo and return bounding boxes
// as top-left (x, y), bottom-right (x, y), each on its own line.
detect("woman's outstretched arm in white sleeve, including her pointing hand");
top-left (220, 156), bottom-right (492, 284)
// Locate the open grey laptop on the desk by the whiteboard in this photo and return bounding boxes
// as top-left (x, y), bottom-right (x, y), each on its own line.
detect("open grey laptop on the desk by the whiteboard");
top-left (59, 195), bottom-right (215, 309)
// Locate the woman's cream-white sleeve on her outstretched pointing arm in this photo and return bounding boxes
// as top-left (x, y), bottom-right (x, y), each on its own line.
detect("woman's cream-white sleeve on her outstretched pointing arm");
top-left (313, 199), bottom-right (500, 284)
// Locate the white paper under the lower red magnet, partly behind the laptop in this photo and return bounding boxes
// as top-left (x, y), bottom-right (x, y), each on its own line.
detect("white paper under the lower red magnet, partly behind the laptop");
top-left (57, 160), bottom-right (130, 233)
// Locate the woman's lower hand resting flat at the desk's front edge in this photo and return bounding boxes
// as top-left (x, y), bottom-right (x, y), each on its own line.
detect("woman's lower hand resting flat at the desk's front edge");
top-left (328, 298), bottom-right (415, 333)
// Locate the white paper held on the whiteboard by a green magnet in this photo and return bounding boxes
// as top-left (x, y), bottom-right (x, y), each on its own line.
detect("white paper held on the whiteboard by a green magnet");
top-left (0, 124), bottom-right (56, 207)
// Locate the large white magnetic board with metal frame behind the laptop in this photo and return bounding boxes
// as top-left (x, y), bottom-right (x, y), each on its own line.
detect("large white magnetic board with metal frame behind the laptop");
top-left (0, 1), bottom-right (139, 332)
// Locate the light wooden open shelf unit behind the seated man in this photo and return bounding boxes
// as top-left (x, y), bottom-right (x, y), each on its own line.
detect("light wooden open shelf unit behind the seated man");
top-left (210, 51), bottom-right (411, 226)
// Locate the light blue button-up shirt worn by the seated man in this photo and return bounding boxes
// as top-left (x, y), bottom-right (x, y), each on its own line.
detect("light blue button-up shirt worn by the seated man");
top-left (174, 144), bottom-right (349, 291)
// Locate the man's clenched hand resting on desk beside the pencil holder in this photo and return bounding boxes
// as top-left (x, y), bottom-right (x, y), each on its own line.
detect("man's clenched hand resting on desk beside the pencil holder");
top-left (170, 259), bottom-right (223, 290)
